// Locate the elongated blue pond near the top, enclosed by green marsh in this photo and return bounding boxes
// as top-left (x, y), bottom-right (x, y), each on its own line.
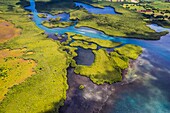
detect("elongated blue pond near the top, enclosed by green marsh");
top-left (75, 2), bottom-right (117, 14)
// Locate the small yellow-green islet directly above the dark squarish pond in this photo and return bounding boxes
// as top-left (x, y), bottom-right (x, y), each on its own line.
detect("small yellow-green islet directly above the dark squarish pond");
top-left (70, 40), bottom-right (97, 49)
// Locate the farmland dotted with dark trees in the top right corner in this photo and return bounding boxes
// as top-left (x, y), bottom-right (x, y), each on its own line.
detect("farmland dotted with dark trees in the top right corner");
top-left (123, 0), bottom-right (170, 28)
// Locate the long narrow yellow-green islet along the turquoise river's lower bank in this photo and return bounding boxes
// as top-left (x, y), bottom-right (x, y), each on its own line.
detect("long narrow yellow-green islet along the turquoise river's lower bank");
top-left (72, 34), bottom-right (121, 48)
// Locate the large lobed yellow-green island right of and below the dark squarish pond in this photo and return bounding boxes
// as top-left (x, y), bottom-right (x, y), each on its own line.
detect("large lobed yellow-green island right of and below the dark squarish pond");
top-left (74, 44), bottom-right (142, 84)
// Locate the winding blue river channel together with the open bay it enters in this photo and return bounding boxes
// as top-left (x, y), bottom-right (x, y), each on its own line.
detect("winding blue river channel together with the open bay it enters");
top-left (24, 0), bottom-right (170, 113)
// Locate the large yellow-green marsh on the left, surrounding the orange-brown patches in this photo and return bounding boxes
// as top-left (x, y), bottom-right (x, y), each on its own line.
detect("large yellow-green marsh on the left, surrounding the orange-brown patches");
top-left (0, 0), bottom-right (69, 113)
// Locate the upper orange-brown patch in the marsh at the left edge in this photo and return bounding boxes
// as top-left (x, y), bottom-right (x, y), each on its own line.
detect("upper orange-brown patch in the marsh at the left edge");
top-left (0, 19), bottom-right (21, 43)
